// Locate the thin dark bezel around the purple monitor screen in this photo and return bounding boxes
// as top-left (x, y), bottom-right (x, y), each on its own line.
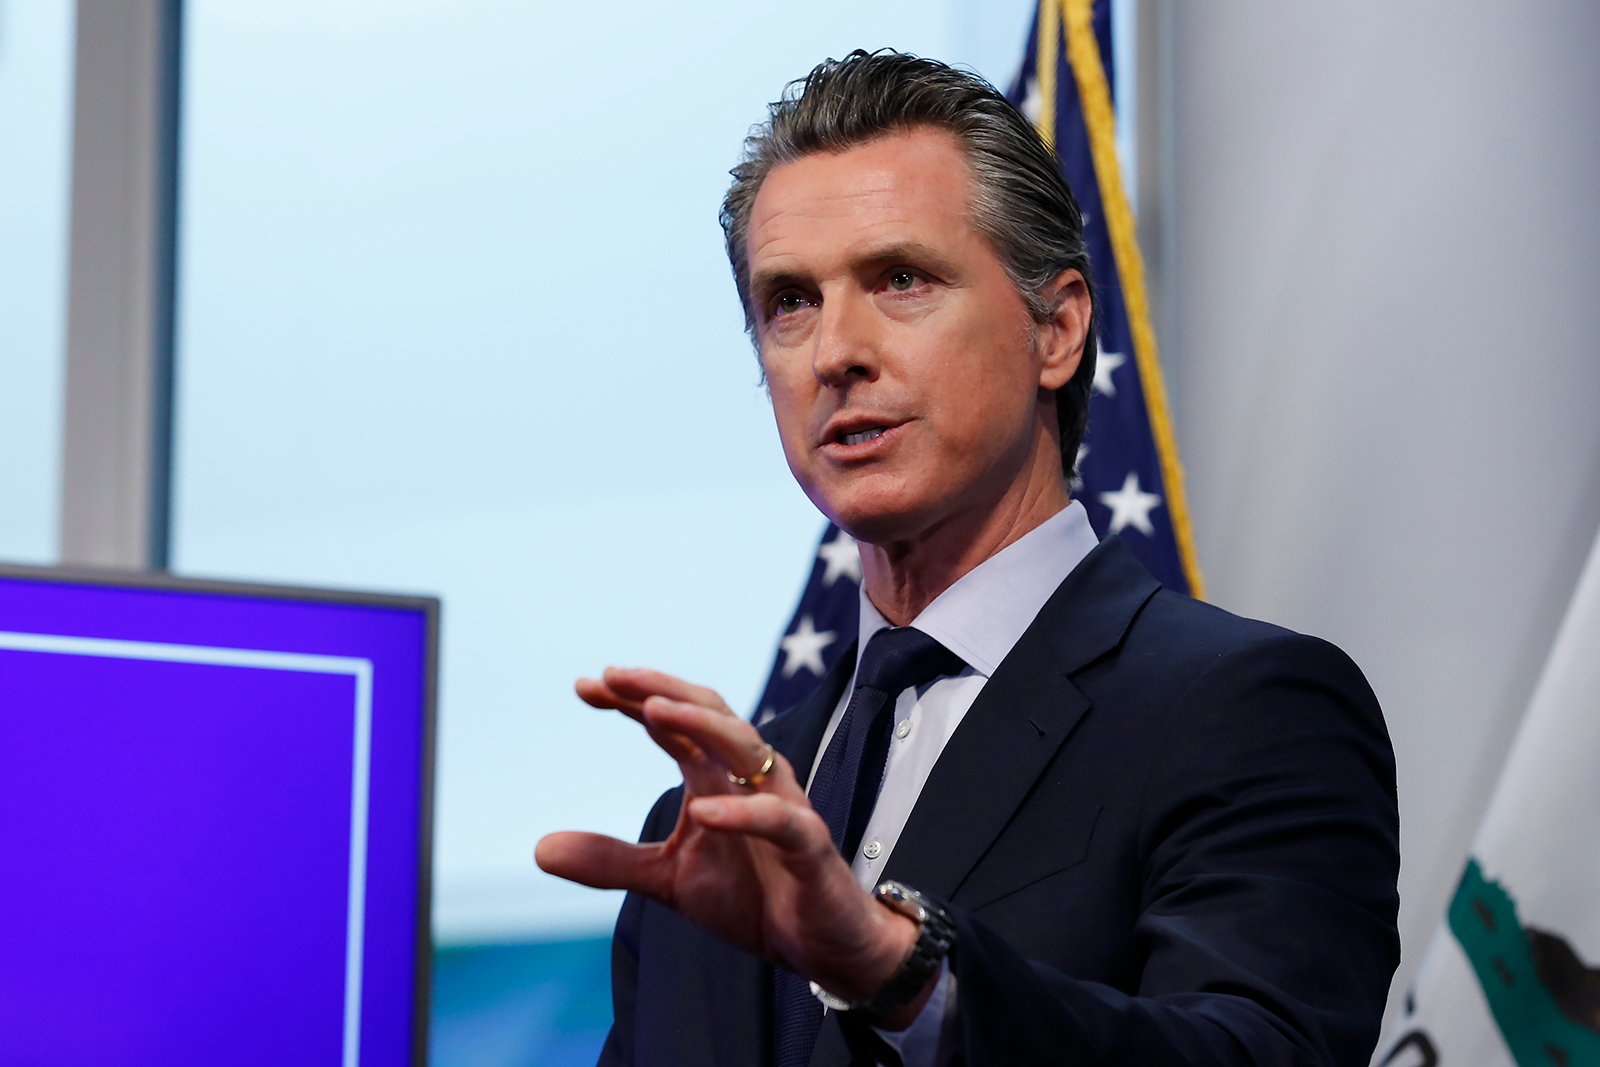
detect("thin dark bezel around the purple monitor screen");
top-left (0, 563), bottom-right (440, 1067)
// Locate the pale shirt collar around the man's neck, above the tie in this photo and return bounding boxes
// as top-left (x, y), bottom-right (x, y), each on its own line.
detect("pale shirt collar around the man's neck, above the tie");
top-left (858, 501), bottom-right (1099, 678)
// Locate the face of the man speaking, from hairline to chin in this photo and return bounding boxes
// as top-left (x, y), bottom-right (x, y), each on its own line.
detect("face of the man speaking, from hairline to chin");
top-left (749, 128), bottom-right (1077, 544)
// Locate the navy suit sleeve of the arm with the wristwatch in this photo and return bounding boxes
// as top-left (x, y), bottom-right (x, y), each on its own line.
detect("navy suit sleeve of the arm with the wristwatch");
top-left (950, 633), bottom-right (1400, 1067)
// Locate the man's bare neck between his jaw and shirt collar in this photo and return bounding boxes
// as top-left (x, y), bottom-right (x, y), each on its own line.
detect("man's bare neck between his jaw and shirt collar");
top-left (861, 475), bottom-right (1072, 625)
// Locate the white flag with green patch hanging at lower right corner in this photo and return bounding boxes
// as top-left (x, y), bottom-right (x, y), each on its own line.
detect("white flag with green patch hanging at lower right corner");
top-left (1374, 524), bottom-right (1600, 1067)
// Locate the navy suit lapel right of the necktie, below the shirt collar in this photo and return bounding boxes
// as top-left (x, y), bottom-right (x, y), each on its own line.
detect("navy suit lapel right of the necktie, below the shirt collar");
top-left (883, 537), bottom-right (1160, 899)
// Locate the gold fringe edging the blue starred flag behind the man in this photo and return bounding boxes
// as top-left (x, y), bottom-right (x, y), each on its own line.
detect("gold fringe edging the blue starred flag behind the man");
top-left (1056, 0), bottom-right (1205, 600)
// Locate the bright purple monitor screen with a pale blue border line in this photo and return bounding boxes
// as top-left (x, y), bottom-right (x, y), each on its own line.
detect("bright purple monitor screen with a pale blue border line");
top-left (0, 576), bottom-right (432, 1067)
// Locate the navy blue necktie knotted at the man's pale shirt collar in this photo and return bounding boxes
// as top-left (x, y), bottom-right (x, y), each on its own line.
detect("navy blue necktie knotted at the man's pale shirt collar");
top-left (774, 625), bottom-right (963, 1067)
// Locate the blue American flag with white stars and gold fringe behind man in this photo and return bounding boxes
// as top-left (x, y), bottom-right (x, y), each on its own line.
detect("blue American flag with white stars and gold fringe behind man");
top-left (755, 0), bottom-right (1202, 723)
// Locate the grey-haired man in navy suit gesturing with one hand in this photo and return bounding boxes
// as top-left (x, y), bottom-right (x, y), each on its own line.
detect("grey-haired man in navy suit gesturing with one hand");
top-left (538, 53), bottom-right (1398, 1067)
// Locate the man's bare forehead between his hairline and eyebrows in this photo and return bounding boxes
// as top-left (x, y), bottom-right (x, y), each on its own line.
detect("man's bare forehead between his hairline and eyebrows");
top-left (749, 130), bottom-right (973, 270)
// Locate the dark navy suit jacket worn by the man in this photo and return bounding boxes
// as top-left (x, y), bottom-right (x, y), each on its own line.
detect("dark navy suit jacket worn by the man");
top-left (600, 539), bottom-right (1400, 1067)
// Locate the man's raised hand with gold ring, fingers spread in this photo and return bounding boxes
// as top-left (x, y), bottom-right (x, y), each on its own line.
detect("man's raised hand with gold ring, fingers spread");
top-left (536, 667), bottom-right (917, 998)
